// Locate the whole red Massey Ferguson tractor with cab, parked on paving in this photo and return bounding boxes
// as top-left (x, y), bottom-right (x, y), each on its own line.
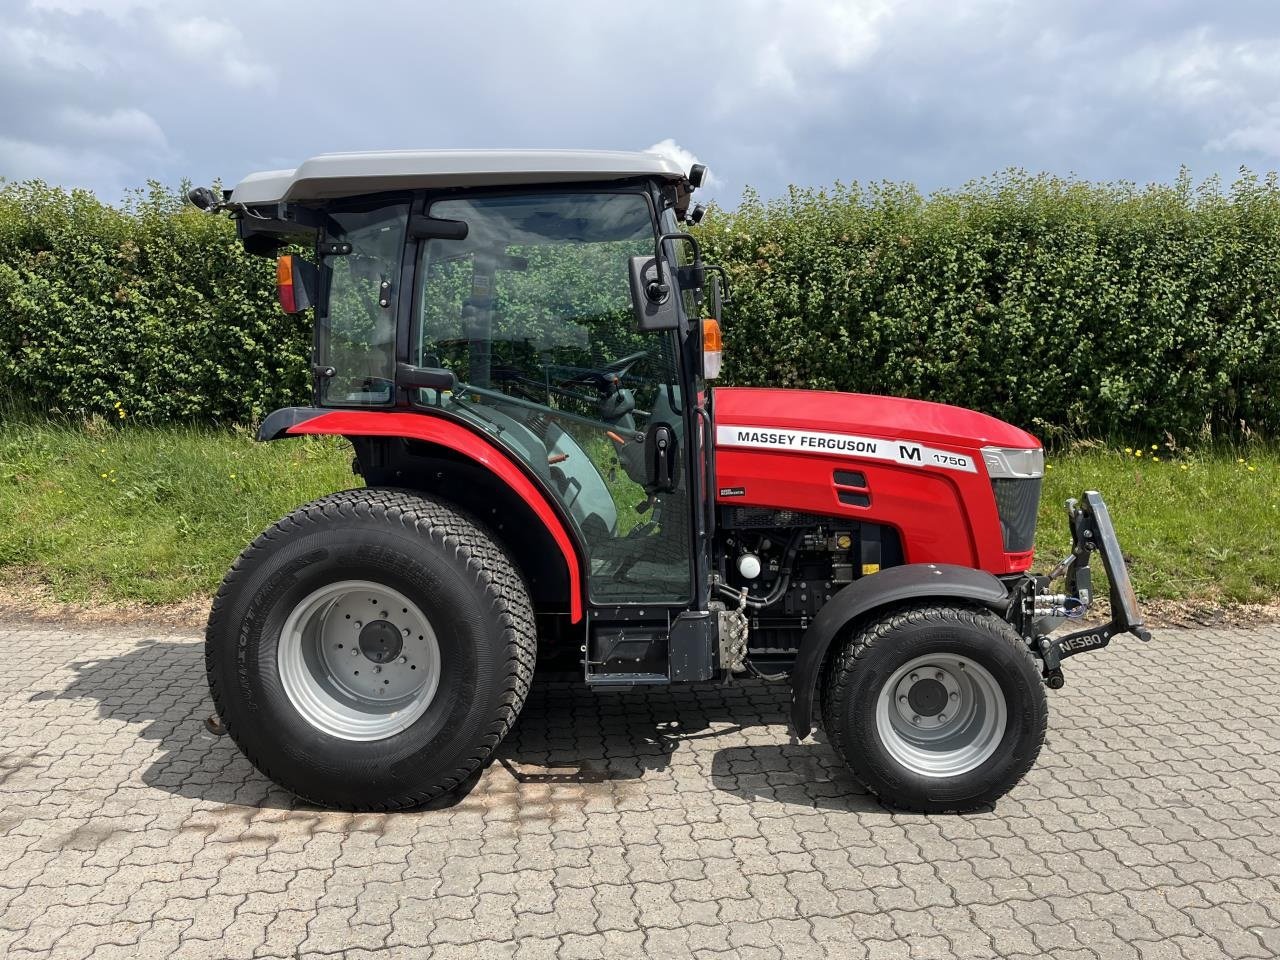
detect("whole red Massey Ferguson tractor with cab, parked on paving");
top-left (191, 151), bottom-right (1148, 812)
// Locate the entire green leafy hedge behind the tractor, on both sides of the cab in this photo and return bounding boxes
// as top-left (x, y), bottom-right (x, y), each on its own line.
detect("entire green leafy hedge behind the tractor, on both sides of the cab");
top-left (0, 173), bottom-right (1280, 439)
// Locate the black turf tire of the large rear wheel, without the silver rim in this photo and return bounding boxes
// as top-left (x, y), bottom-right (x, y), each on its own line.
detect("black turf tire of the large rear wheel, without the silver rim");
top-left (205, 488), bottom-right (536, 810)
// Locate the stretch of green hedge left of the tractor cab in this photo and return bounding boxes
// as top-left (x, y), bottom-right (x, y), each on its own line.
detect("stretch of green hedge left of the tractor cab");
top-left (0, 183), bottom-right (311, 422)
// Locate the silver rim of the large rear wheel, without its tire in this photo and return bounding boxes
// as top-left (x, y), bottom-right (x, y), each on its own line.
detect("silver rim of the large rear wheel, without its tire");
top-left (276, 580), bottom-right (440, 740)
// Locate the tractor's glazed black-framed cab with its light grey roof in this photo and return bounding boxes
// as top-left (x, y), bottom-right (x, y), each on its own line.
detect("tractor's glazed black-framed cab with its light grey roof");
top-left (204, 151), bottom-right (718, 624)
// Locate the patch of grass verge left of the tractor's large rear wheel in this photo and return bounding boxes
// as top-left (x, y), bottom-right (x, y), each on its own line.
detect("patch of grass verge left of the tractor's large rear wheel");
top-left (0, 420), bottom-right (358, 604)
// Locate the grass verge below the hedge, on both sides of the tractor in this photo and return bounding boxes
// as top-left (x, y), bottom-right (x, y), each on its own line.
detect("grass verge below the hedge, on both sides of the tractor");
top-left (0, 419), bottom-right (1280, 604)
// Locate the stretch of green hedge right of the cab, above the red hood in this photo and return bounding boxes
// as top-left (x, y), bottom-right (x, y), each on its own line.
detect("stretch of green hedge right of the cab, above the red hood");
top-left (701, 173), bottom-right (1280, 439)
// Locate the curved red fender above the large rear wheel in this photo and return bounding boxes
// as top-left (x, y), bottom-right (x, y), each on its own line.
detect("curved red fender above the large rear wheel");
top-left (257, 407), bottom-right (582, 623)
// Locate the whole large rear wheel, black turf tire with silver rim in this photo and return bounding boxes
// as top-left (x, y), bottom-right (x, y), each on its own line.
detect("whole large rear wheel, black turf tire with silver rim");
top-left (205, 489), bottom-right (535, 809)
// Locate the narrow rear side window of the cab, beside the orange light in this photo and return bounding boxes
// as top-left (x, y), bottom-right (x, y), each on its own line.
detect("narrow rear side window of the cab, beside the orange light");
top-left (316, 204), bottom-right (408, 406)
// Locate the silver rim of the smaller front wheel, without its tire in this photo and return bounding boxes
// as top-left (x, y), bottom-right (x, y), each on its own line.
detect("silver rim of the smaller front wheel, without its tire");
top-left (876, 654), bottom-right (1009, 777)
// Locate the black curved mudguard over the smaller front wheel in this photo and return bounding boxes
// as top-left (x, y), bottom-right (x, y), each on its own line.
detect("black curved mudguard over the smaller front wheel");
top-left (791, 563), bottom-right (1009, 740)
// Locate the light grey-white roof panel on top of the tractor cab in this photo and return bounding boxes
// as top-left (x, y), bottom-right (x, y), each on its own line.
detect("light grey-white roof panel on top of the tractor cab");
top-left (232, 150), bottom-right (689, 205)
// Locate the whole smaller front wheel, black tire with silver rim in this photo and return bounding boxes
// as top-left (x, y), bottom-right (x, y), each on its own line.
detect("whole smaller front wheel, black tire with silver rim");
top-left (822, 605), bottom-right (1048, 813)
